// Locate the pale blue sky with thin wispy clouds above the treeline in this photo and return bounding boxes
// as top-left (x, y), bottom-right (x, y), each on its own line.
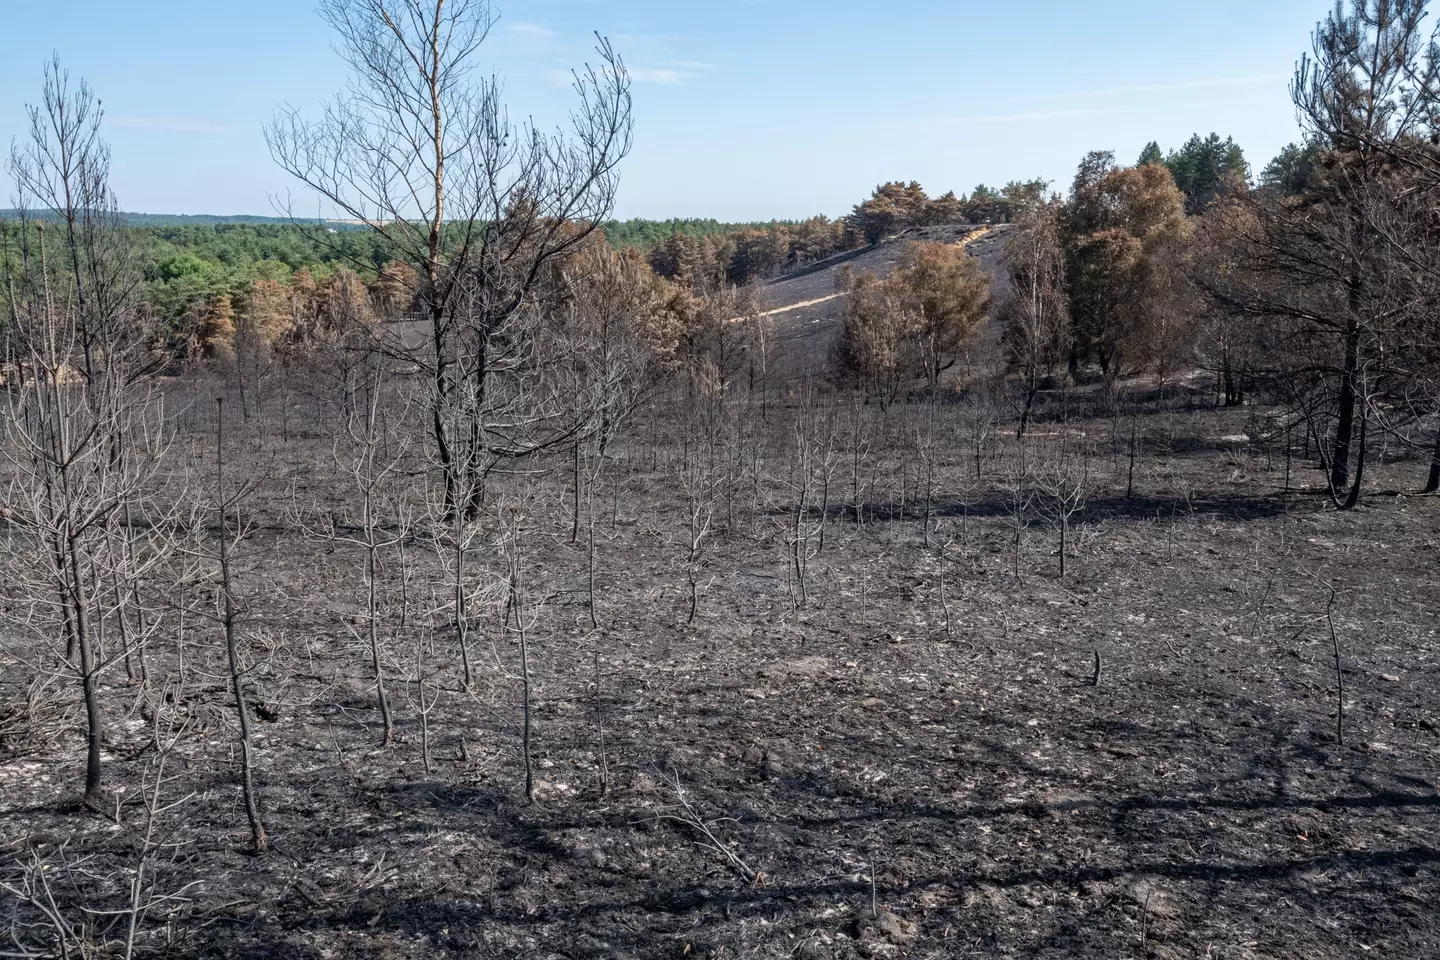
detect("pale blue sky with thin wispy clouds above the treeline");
top-left (0, 0), bottom-right (1331, 220)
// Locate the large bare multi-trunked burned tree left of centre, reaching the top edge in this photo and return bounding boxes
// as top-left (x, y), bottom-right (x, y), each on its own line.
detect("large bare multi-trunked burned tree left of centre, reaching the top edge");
top-left (266, 0), bottom-right (631, 518)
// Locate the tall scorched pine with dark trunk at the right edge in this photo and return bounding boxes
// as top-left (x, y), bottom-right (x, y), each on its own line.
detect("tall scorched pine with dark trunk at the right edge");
top-left (1207, 0), bottom-right (1440, 507)
